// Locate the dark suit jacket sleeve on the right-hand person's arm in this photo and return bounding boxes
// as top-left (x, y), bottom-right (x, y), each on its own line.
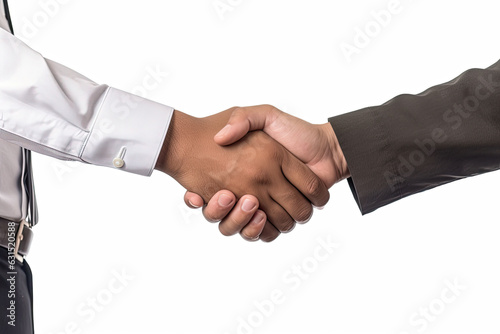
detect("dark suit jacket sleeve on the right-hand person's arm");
top-left (329, 61), bottom-right (500, 214)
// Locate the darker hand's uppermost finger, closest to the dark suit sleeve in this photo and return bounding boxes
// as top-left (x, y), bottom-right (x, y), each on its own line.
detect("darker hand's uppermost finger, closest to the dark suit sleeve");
top-left (281, 154), bottom-right (330, 207)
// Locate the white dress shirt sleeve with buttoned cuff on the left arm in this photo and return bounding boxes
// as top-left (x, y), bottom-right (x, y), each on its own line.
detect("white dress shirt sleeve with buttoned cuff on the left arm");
top-left (0, 29), bottom-right (173, 176)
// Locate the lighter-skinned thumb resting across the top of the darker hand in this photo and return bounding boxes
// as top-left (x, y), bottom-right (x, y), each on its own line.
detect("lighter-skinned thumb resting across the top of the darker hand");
top-left (214, 105), bottom-right (278, 146)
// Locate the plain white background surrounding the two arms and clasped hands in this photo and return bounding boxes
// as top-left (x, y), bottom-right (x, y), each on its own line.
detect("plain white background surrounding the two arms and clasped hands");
top-left (6, 0), bottom-right (500, 334)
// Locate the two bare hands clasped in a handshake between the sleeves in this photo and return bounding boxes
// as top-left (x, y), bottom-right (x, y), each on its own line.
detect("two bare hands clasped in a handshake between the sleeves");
top-left (156, 105), bottom-right (349, 242)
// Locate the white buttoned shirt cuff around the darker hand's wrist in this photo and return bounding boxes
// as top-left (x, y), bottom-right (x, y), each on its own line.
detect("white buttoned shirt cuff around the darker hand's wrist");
top-left (80, 87), bottom-right (174, 176)
